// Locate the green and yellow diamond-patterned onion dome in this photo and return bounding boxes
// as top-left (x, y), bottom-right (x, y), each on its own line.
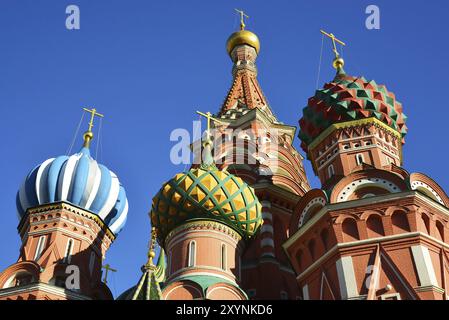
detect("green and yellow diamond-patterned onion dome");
top-left (150, 165), bottom-right (263, 242)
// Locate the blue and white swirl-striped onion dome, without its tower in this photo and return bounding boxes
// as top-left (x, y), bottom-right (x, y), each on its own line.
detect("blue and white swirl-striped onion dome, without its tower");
top-left (17, 147), bottom-right (128, 234)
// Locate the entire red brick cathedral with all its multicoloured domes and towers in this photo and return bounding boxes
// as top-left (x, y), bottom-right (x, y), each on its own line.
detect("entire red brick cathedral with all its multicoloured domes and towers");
top-left (0, 11), bottom-right (449, 300)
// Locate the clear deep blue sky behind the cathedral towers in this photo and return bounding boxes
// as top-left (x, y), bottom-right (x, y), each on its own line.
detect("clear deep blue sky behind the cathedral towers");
top-left (0, 0), bottom-right (449, 295)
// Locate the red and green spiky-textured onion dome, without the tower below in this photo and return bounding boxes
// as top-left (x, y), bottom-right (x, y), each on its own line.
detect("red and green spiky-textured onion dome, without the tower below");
top-left (298, 70), bottom-right (407, 152)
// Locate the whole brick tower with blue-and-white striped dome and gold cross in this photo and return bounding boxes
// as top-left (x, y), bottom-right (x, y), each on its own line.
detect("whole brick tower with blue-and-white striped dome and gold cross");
top-left (0, 109), bottom-right (128, 300)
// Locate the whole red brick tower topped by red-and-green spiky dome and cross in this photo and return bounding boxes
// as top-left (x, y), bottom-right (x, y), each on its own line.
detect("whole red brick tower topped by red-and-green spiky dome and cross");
top-left (284, 34), bottom-right (449, 300)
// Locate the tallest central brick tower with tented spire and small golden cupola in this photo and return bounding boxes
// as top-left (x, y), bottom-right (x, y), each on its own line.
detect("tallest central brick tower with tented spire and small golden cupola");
top-left (200, 15), bottom-right (310, 299)
